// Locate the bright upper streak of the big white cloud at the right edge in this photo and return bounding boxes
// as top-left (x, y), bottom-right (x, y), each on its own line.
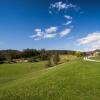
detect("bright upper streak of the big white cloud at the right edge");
top-left (77, 32), bottom-right (100, 45)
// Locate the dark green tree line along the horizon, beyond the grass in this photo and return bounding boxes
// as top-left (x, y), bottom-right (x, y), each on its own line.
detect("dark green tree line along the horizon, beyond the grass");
top-left (0, 49), bottom-right (85, 65)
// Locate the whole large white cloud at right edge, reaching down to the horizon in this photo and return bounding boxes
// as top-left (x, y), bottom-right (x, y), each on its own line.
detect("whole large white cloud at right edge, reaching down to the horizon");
top-left (77, 32), bottom-right (100, 51)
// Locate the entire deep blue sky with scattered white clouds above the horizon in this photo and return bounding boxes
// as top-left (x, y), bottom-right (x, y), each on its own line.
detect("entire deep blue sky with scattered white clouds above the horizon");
top-left (0, 0), bottom-right (100, 51)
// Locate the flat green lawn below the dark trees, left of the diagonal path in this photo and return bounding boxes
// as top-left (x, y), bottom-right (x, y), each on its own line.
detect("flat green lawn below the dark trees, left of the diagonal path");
top-left (0, 62), bottom-right (46, 86)
